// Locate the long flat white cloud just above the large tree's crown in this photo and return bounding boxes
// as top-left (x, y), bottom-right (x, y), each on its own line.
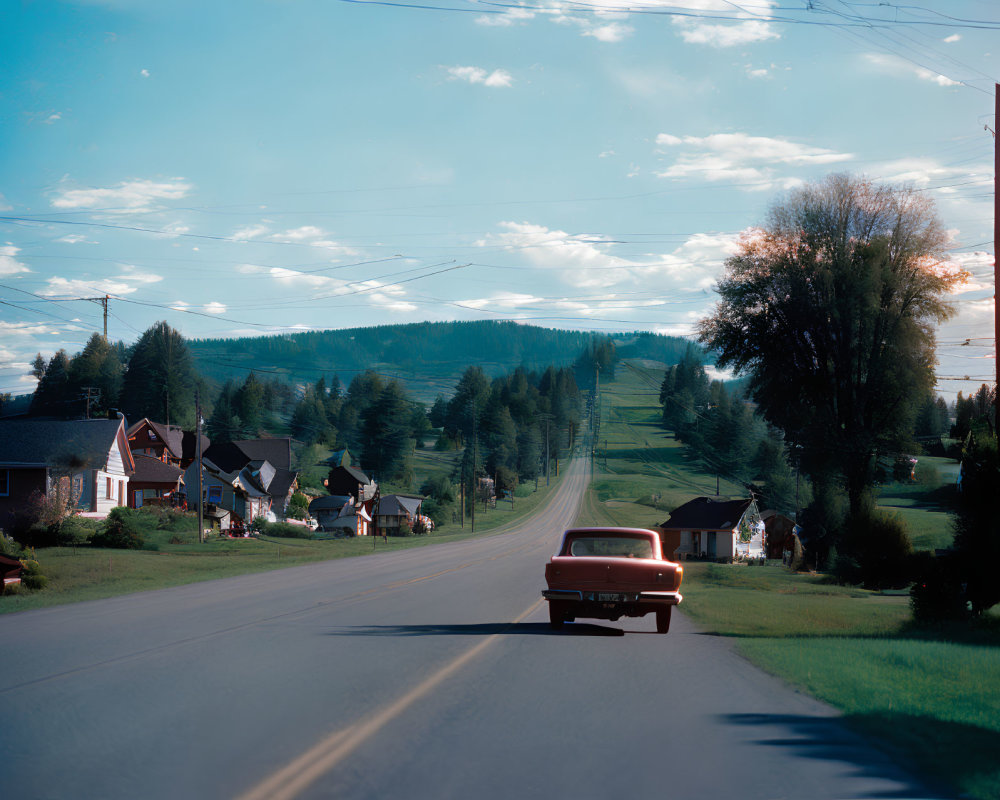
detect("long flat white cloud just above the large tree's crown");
top-left (656, 133), bottom-right (854, 191)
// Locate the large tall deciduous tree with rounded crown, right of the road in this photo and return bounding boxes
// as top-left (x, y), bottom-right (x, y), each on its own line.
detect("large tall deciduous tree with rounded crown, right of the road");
top-left (699, 175), bottom-right (963, 514)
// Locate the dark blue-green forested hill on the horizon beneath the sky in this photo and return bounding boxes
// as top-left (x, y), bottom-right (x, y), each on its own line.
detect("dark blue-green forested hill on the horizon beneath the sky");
top-left (188, 320), bottom-right (688, 400)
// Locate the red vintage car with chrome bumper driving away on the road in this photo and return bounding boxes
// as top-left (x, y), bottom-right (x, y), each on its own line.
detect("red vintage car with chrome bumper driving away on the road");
top-left (542, 528), bottom-right (684, 633)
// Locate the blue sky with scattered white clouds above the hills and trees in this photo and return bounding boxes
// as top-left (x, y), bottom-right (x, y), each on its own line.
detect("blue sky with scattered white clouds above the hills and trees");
top-left (0, 0), bottom-right (1000, 399)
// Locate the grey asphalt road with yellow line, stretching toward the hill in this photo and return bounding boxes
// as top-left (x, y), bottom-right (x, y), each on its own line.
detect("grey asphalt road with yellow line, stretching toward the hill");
top-left (0, 460), bottom-right (934, 800)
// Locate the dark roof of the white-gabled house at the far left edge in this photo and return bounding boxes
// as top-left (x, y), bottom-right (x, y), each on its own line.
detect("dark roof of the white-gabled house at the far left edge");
top-left (0, 417), bottom-right (129, 471)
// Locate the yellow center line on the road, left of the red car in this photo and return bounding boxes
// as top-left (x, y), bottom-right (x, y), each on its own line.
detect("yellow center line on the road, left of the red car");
top-left (238, 600), bottom-right (542, 800)
